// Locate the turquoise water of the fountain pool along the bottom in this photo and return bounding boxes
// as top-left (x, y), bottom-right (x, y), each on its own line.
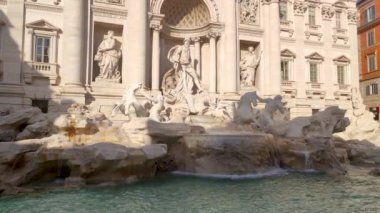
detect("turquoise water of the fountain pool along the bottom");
top-left (0, 174), bottom-right (380, 213)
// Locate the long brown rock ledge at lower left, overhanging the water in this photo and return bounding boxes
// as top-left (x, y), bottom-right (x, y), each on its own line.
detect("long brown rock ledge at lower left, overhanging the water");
top-left (0, 136), bottom-right (167, 194)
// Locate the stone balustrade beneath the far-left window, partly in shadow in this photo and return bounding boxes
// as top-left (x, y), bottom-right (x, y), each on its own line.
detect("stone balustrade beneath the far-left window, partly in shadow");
top-left (24, 61), bottom-right (59, 85)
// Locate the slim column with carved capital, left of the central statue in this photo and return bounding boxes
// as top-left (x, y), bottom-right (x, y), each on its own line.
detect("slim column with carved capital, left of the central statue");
top-left (150, 24), bottom-right (162, 91)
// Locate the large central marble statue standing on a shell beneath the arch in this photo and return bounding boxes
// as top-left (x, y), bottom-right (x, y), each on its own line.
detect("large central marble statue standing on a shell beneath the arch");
top-left (162, 38), bottom-right (203, 114)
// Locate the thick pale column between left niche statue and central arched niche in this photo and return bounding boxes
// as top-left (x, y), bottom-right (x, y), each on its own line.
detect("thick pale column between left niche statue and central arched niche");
top-left (122, 0), bottom-right (149, 85)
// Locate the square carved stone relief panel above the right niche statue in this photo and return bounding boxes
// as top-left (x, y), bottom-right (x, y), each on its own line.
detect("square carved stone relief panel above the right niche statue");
top-left (240, 0), bottom-right (259, 24)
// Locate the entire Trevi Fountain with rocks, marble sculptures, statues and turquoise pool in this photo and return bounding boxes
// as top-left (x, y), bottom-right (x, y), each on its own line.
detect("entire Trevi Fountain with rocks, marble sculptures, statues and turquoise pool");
top-left (0, 38), bottom-right (380, 212)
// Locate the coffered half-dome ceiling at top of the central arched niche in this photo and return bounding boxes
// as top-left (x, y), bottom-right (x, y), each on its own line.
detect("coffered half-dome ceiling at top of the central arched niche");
top-left (160, 0), bottom-right (211, 29)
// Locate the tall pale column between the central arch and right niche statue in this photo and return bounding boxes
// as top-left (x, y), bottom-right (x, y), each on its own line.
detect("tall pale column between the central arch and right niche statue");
top-left (221, 0), bottom-right (239, 93)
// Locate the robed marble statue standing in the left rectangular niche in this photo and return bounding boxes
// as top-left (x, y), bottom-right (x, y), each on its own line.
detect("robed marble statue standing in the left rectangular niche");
top-left (94, 30), bottom-right (121, 83)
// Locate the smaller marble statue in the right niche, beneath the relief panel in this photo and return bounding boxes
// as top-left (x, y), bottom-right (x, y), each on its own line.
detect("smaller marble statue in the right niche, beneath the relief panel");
top-left (240, 46), bottom-right (262, 87)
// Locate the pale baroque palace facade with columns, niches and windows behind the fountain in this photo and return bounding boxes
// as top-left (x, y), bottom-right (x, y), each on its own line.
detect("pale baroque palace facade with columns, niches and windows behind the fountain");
top-left (0, 0), bottom-right (359, 116)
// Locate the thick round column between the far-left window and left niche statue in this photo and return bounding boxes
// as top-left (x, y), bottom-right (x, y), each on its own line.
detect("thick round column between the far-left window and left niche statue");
top-left (61, 0), bottom-right (87, 86)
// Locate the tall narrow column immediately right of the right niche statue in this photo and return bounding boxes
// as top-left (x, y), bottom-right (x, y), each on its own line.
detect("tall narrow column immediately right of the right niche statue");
top-left (264, 0), bottom-right (281, 95)
